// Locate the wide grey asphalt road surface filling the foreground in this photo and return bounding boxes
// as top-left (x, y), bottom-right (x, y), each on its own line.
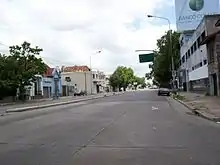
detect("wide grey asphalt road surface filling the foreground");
top-left (0, 91), bottom-right (220, 165)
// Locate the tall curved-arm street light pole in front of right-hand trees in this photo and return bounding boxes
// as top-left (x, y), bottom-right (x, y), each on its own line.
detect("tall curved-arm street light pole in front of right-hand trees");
top-left (147, 15), bottom-right (175, 87)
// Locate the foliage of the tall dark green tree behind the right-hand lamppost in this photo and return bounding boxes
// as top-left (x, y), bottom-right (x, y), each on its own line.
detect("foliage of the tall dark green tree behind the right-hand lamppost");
top-left (145, 31), bottom-right (180, 84)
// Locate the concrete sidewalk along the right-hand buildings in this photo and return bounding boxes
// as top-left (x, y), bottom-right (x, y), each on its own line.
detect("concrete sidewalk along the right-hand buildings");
top-left (173, 92), bottom-right (220, 122)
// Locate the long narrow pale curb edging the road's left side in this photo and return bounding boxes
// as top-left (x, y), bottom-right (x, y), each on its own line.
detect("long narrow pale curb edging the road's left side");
top-left (5, 93), bottom-right (122, 113)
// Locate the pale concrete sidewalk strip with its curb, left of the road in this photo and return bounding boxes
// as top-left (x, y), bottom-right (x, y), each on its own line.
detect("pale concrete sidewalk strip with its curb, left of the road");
top-left (0, 93), bottom-right (120, 114)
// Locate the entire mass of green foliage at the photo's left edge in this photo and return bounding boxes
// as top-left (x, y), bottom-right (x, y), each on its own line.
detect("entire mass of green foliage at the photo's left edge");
top-left (0, 42), bottom-right (46, 100)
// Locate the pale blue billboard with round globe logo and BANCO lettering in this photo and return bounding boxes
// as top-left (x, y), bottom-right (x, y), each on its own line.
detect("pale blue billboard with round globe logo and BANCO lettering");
top-left (175, 0), bottom-right (220, 32)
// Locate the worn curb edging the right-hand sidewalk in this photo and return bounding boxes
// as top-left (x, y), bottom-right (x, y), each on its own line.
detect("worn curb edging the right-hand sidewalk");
top-left (170, 97), bottom-right (220, 122)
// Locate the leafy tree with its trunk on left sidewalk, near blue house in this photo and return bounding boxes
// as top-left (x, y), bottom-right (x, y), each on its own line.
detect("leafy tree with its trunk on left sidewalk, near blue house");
top-left (8, 41), bottom-right (46, 100)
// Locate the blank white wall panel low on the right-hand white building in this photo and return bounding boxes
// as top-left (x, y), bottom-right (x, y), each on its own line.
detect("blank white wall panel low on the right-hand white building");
top-left (189, 65), bottom-right (208, 81)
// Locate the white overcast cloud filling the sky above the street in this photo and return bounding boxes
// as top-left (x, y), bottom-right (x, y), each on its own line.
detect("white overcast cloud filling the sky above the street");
top-left (0, 0), bottom-right (173, 76)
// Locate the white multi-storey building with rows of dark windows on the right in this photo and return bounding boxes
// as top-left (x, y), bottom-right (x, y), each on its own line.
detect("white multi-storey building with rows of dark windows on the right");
top-left (179, 15), bottom-right (219, 91)
